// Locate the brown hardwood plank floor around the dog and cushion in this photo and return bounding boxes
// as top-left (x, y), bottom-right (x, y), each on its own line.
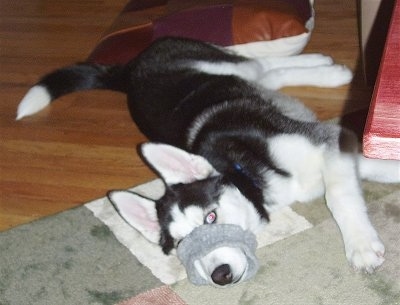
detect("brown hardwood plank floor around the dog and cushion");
top-left (0, 0), bottom-right (370, 230)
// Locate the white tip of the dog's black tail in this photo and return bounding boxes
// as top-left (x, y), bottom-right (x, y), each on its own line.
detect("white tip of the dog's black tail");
top-left (16, 85), bottom-right (51, 120)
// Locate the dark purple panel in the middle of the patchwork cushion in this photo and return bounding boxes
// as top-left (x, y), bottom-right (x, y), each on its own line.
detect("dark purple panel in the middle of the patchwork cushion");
top-left (153, 5), bottom-right (233, 46)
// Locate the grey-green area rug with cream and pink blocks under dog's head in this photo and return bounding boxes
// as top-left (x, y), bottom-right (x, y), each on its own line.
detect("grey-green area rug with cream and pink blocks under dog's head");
top-left (0, 180), bottom-right (400, 305)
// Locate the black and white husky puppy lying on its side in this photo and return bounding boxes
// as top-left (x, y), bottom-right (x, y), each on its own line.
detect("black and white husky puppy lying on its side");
top-left (17, 38), bottom-right (400, 285)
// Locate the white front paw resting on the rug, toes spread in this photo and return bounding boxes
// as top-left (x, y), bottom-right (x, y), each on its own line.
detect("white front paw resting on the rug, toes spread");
top-left (346, 237), bottom-right (385, 273)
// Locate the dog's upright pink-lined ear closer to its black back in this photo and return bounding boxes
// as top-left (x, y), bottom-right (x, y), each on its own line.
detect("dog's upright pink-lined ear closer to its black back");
top-left (140, 143), bottom-right (216, 185)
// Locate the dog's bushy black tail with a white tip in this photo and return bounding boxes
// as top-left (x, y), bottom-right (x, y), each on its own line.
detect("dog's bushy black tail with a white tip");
top-left (17, 63), bottom-right (128, 120)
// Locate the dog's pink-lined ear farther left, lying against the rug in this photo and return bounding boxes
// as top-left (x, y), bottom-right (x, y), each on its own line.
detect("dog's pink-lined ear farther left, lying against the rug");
top-left (107, 191), bottom-right (160, 244)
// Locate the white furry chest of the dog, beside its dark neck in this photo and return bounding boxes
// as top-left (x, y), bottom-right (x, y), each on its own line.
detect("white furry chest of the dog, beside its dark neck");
top-left (263, 135), bottom-right (325, 211)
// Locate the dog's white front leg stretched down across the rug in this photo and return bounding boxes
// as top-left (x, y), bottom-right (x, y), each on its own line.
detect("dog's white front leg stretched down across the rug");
top-left (323, 151), bottom-right (385, 273)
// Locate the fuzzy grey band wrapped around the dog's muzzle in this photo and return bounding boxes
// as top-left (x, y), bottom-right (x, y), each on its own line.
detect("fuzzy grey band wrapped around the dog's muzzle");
top-left (177, 224), bottom-right (258, 286)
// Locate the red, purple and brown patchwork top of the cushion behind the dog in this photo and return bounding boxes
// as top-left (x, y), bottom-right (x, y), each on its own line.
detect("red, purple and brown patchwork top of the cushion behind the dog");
top-left (88, 0), bottom-right (312, 64)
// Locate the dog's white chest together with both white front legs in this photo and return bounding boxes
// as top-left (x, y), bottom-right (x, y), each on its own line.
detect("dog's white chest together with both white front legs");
top-left (264, 135), bottom-right (394, 272)
